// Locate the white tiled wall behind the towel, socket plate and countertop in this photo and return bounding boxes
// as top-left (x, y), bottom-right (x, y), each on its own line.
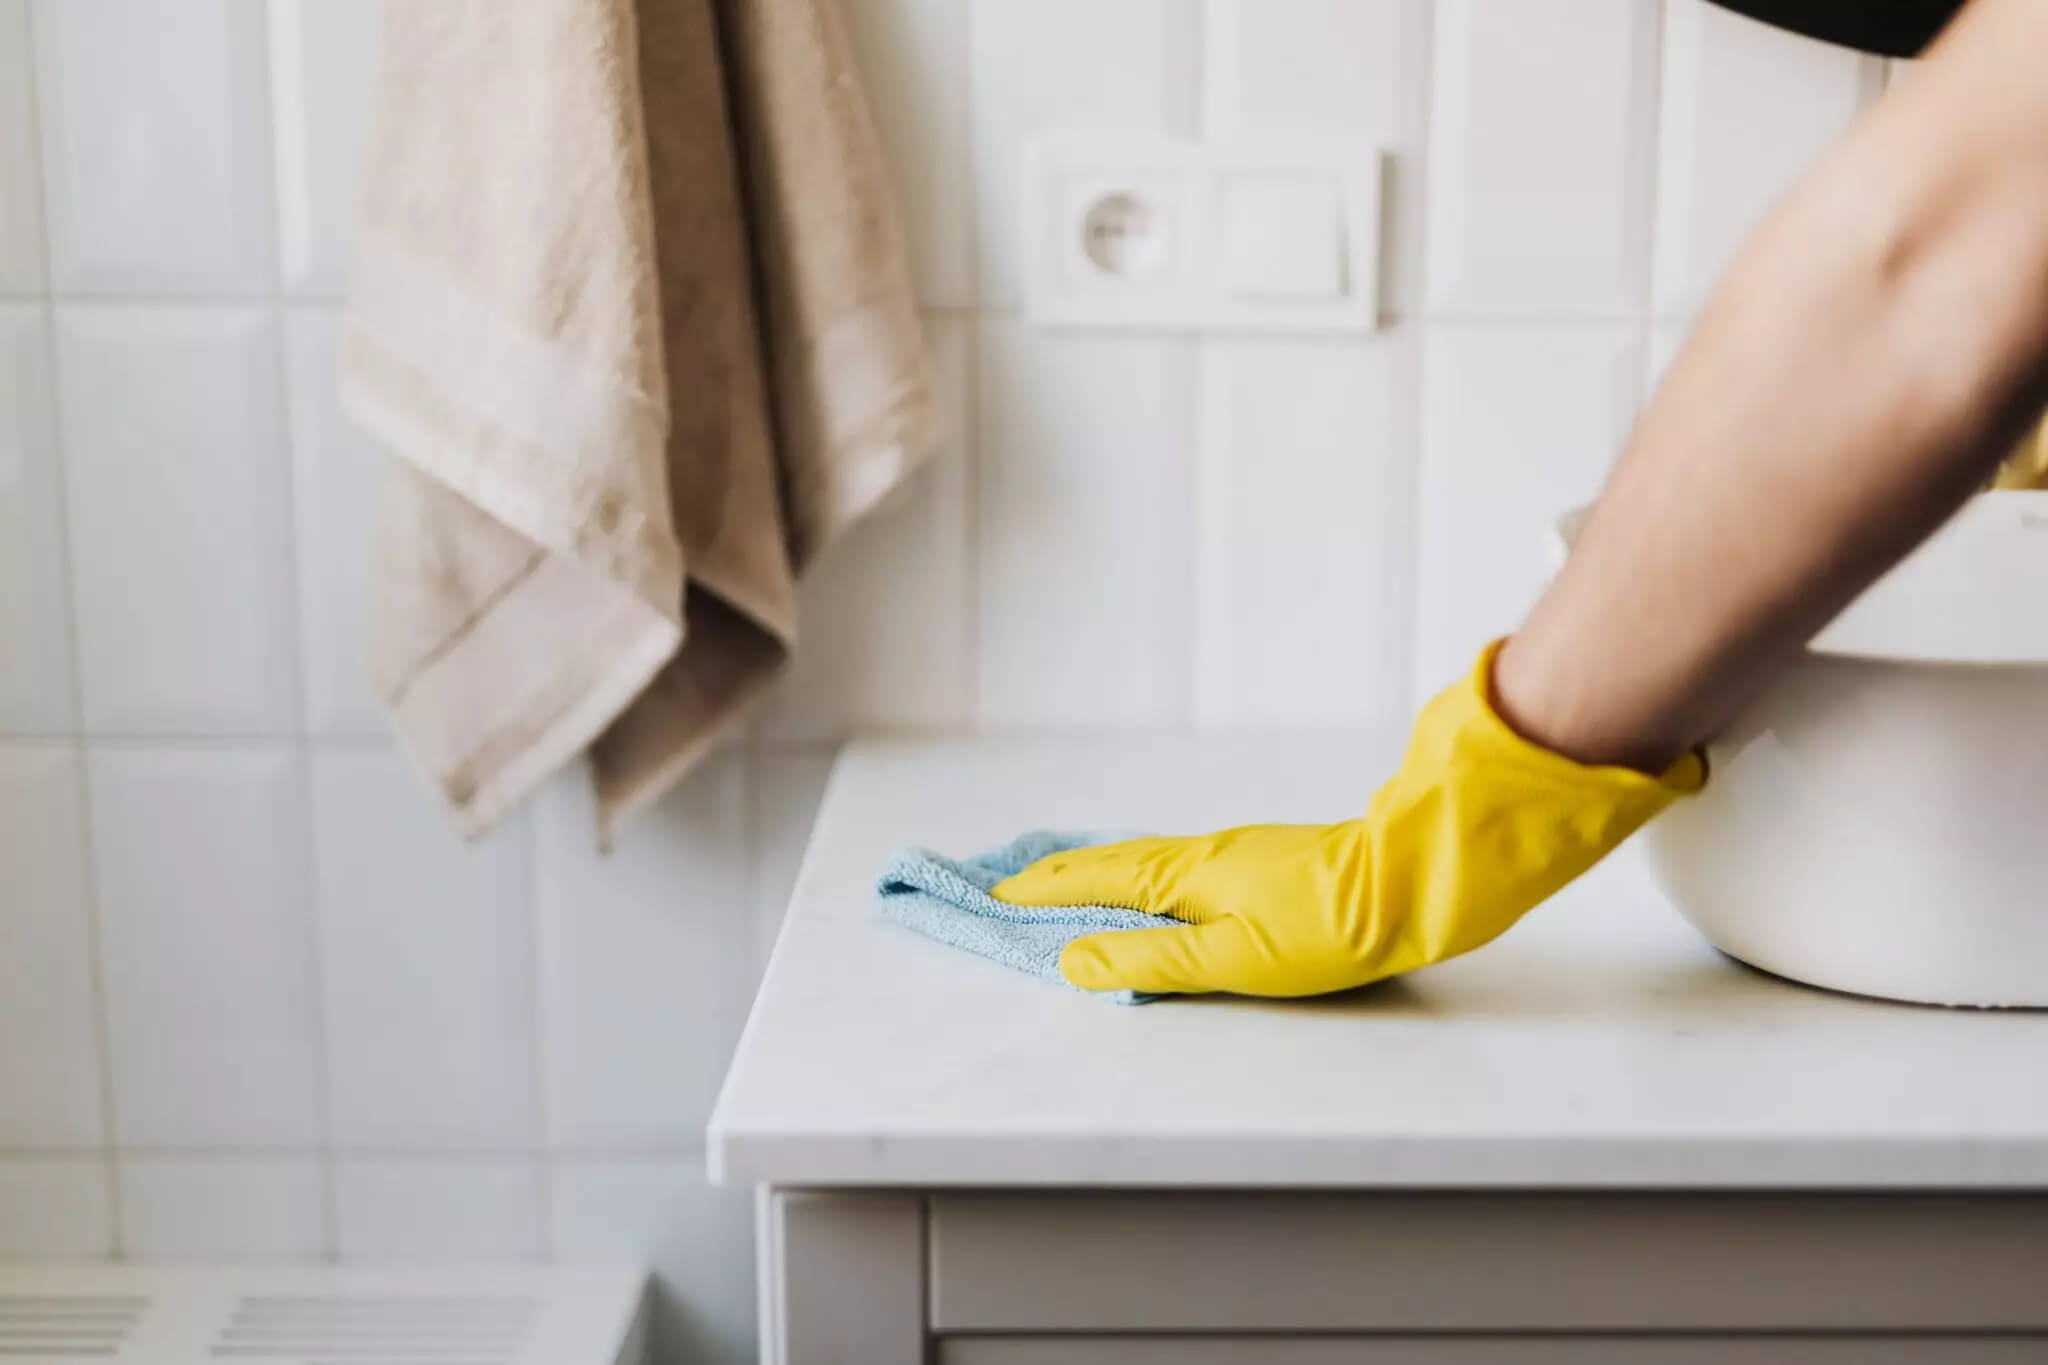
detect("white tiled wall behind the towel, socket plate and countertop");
top-left (0, 0), bottom-right (1878, 1365)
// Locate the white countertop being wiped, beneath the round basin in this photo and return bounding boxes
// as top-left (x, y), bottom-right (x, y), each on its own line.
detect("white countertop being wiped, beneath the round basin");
top-left (709, 735), bottom-right (2048, 1187)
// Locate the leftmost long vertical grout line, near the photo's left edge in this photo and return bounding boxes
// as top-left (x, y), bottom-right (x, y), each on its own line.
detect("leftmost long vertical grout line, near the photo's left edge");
top-left (23, 4), bottom-right (125, 1259)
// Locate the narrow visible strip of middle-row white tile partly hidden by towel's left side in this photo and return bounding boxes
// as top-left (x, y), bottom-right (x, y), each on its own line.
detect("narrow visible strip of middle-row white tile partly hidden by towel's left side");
top-left (285, 309), bottom-right (385, 735)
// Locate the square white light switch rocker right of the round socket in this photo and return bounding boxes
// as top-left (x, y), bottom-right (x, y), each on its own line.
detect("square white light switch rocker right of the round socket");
top-left (1221, 174), bottom-right (1343, 299)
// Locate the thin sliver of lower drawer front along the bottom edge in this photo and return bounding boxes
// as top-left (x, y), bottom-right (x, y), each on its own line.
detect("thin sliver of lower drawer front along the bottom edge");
top-left (938, 1336), bottom-right (2048, 1365)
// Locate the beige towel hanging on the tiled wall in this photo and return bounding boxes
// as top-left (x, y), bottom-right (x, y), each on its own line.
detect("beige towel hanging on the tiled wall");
top-left (342, 0), bottom-right (934, 833)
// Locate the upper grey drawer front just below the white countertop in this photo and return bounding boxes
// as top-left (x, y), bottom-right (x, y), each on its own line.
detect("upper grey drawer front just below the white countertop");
top-left (928, 1193), bottom-right (2048, 1334)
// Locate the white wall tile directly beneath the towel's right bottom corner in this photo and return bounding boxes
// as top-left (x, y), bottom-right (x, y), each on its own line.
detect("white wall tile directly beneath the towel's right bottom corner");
top-left (535, 753), bottom-right (756, 1148)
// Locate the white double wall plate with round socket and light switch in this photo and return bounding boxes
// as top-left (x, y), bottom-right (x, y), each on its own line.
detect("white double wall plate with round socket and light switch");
top-left (1022, 133), bottom-right (1382, 332)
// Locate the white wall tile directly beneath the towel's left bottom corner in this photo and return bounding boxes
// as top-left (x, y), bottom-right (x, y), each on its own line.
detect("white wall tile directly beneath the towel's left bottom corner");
top-left (313, 751), bottom-right (537, 1148)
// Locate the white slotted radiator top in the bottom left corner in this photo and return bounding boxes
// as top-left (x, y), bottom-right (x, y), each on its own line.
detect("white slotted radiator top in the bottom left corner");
top-left (0, 1265), bottom-right (647, 1365)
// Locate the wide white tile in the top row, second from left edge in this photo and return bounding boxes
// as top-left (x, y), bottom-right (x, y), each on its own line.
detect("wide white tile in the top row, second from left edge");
top-left (33, 0), bottom-right (272, 293)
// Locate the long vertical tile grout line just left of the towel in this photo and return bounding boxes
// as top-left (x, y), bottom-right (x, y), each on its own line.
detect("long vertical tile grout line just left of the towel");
top-left (260, 4), bottom-right (340, 1261)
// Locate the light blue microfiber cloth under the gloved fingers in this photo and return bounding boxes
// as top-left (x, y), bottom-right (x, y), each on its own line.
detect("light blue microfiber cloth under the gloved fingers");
top-left (874, 829), bottom-right (1178, 1005)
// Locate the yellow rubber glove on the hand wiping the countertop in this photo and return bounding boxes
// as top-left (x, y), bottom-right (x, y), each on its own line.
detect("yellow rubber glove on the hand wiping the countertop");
top-left (995, 645), bottom-right (1706, 995)
